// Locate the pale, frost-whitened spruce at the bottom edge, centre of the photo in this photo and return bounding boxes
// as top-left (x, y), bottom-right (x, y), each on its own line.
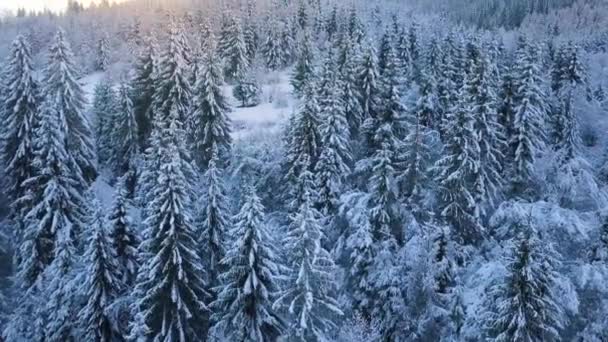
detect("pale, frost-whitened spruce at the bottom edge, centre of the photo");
top-left (273, 171), bottom-right (342, 341)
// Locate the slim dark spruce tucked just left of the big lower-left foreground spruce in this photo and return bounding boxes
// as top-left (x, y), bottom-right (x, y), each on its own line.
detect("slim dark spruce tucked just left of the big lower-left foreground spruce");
top-left (108, 177), bottom-right (139, 288)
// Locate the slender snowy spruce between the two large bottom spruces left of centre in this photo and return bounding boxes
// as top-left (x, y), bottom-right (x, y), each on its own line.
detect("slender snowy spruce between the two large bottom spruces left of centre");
top-left (197, 146), bottom-right (230, 287)
